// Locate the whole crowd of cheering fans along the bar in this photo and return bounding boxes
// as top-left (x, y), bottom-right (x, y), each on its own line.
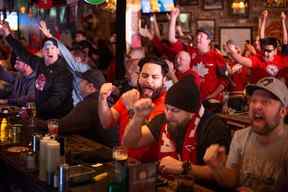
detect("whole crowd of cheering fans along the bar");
top-left (0, 8), bottom-right (288, 192)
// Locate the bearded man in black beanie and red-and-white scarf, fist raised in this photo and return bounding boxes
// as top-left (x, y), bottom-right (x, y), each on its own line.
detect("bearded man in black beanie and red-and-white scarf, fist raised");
top-left (123, 76), bottom-right (231, 178)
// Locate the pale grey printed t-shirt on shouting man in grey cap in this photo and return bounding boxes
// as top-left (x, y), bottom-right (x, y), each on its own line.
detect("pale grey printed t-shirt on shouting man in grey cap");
top-left (226, 126), bottom-right (288, 192)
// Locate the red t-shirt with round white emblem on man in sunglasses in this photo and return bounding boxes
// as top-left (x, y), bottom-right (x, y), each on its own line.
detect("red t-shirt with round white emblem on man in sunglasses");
top-left (250, 55), bottom-right (288, 83)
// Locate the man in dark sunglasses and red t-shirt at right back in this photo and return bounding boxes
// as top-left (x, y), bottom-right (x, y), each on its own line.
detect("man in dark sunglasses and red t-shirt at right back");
top-left (227, 37), bottom-right (288, 83)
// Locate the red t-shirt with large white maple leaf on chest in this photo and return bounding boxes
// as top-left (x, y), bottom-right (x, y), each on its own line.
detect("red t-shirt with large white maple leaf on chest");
top-left (169, 41), bottom-right (228, 101)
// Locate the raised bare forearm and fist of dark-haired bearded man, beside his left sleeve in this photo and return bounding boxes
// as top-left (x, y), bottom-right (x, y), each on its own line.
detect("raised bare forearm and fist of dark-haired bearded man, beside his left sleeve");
top-left (98, 83), bottom-right (119, 128)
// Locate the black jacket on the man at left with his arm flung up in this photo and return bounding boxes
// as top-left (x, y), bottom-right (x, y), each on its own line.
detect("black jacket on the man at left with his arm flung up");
top-left (6, 35), bottom-right (73, 119)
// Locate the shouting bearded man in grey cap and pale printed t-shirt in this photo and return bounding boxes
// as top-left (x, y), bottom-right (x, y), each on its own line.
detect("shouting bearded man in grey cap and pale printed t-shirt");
top-left (204, 77), bottom-right (288, 192)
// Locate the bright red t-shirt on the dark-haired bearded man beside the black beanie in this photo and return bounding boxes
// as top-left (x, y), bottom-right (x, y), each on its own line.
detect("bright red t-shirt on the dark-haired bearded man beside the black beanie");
top-left (113, 92), bottom-right (166, 162)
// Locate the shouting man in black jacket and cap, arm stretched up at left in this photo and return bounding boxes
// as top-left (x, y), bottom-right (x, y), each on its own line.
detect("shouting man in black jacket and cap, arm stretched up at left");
top-left (0, 23), bottom-right (73, 120)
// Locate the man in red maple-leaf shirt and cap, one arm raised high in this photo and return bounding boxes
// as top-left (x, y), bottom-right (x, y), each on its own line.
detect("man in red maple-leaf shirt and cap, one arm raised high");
top-left (169, 8), bottom-right (227, 101)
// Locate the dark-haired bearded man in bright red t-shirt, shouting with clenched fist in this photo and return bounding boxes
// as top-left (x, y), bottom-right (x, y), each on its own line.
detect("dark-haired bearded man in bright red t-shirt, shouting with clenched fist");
top-left (98, 57), bottom-right (168, 161)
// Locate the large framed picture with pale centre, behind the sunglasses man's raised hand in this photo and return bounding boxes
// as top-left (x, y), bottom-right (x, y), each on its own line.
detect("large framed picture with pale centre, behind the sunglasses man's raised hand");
top-left (219, 27), bottom-right (253, 51)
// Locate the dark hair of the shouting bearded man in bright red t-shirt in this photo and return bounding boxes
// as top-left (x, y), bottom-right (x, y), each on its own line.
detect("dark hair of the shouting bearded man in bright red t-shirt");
top-left (138, 56), bottom-right (169, 76)
